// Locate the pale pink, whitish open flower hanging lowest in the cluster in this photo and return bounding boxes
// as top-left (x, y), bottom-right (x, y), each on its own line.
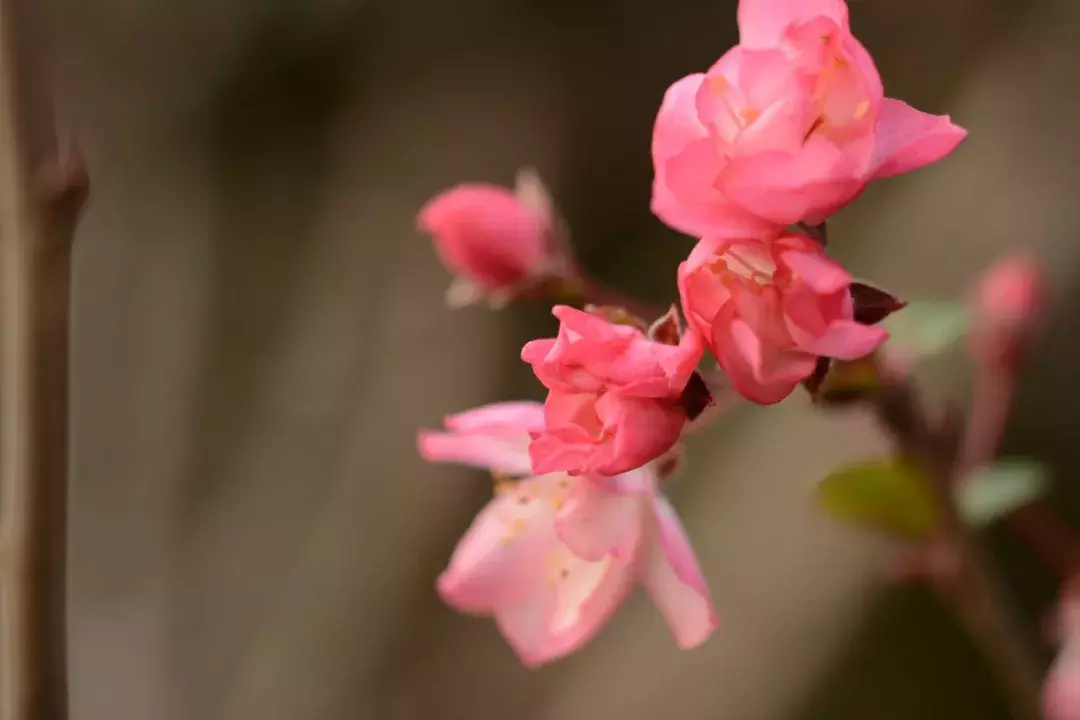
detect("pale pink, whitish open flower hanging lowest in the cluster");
top-left (419, 403), bottom-right (717, 667)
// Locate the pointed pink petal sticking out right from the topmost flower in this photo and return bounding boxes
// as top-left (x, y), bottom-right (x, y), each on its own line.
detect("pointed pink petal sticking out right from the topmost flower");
top-left (874, 98), bottom-right (968, 177)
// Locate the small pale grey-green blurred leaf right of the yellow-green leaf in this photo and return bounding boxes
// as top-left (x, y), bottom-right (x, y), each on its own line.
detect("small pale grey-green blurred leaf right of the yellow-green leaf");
top-left (957, 458), bottom-right (1050, 527)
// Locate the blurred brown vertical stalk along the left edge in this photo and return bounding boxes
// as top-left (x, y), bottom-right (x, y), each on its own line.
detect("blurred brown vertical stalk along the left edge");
top-left (0, 0), bottom-right (86, 720)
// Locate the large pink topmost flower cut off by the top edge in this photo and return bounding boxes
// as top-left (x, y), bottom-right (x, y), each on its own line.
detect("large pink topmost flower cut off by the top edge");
top-left (652, 0), bottom-right (967, 236)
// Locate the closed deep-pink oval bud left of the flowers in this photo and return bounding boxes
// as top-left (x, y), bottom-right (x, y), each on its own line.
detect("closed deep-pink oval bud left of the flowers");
top-left (417, 185), bottom-right (550, 305)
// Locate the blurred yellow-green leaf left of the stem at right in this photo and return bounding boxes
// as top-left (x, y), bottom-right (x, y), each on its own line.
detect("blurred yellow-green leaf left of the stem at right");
top-left (815, 458), bottom-right (939, 539)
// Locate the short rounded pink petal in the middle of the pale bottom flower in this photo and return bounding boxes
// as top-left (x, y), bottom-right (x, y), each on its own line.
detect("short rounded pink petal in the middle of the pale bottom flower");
top-left (555, 477), bottom-right (639, 563)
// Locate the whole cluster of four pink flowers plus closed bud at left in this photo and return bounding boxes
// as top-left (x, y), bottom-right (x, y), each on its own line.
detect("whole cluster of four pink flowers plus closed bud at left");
top-left (419, 0), bottom-right (966, 665)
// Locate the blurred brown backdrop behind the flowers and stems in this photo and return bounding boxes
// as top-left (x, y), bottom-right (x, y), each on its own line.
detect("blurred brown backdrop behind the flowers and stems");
top-left (51, 0), bottom-right (1080, 720)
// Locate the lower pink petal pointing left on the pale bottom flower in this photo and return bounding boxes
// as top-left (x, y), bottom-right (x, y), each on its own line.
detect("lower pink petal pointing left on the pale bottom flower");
top-left (417, 430), bottom-right (532, 475)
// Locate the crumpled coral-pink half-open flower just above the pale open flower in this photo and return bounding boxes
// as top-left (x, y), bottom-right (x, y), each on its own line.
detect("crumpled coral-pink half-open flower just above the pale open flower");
top-left (522, 305), bottom-right (704, 475)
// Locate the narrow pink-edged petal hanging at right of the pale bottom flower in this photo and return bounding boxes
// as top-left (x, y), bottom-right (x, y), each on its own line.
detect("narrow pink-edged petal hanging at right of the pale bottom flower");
top-left (643, 495), bottom-right (719, 650)
